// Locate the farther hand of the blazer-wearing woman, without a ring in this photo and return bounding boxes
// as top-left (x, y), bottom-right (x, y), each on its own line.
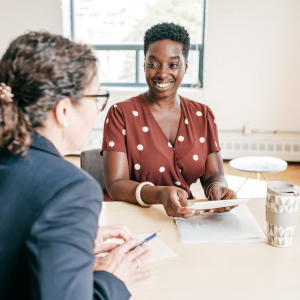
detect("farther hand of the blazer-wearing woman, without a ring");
top-left (94, 225), bottom-right (133, 254)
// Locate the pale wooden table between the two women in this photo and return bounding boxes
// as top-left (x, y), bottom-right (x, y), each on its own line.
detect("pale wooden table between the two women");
top-left (100, 198), bottom-right (300, 300)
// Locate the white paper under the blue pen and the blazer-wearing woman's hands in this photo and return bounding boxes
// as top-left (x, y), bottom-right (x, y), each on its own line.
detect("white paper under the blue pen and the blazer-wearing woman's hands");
top-left (97, 233), bottom-right (177, 261)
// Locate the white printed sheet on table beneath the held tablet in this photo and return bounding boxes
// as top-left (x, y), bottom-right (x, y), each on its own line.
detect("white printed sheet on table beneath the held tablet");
top-left (174, 204), bottom-right (266, 243)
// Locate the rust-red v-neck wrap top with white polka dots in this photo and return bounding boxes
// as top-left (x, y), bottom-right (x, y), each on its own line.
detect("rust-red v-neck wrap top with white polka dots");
top-left (101, 95), bottom-right (221, 200)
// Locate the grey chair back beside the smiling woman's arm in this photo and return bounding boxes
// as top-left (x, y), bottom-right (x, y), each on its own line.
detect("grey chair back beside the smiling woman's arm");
top-left (80, 149), bottom-right (105, 188)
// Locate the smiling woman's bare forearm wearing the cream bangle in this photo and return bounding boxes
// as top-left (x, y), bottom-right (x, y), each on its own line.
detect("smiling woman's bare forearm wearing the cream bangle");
top-left (107, 179), bottom-right (161, 204)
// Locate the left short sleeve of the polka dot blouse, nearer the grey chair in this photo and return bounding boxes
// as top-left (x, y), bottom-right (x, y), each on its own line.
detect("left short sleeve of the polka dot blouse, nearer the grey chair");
top-left (101, 105), bottom-right (127, 155)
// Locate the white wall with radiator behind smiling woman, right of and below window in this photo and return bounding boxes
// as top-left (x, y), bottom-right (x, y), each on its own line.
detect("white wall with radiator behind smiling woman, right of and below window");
top-left (94, 0), bottom-right (300, 161)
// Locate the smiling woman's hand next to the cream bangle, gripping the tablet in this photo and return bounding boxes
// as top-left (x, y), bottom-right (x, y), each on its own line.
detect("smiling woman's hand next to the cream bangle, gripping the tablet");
top-left (156, 186), bottom-right (200, 218)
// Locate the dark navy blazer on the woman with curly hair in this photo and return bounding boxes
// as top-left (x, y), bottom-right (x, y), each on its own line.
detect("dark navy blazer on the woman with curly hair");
top-left (0, 133), bottom-right (130, 300)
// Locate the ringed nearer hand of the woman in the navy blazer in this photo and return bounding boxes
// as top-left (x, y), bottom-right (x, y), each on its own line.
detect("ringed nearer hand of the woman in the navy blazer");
top-left (93, 238), bottom-right (154, 287)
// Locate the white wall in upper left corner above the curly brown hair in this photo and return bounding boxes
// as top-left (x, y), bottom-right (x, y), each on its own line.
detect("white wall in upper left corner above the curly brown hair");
top-left (0, 0), bottom-right (63, 57)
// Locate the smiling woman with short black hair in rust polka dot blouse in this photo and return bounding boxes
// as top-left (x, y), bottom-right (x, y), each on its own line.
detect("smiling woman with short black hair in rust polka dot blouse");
top-left (102, 23), bottom-right (236, 218)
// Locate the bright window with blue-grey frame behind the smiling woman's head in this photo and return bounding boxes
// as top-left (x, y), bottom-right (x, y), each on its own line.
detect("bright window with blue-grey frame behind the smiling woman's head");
top-left (71, 0), bottom-right (205, 86)
